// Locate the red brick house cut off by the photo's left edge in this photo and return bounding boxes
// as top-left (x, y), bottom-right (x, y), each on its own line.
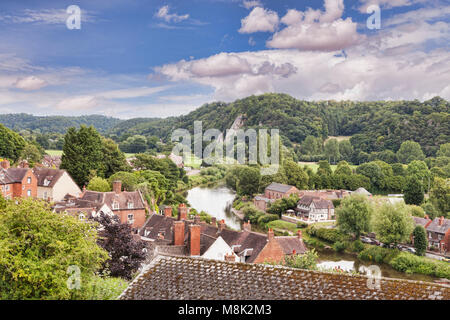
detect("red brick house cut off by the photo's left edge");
top-left (0, 160), bottom-right (37, 199)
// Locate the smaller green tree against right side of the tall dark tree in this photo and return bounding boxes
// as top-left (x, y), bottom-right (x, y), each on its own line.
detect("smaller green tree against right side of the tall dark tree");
top-left (101, 138), bottom-right (131, 178)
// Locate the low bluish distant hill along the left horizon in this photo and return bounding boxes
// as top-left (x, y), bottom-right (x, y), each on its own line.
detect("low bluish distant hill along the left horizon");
top-left (0, 113), bottom-right (122, 133)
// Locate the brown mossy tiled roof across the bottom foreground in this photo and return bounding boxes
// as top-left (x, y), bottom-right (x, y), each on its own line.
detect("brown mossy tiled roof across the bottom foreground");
top-left (119, 254), bottom-right (450, 300)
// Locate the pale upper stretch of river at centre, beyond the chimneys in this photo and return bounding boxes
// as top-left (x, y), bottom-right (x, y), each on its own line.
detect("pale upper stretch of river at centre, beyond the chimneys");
top-left (186, 185), bottom-right (241, 230)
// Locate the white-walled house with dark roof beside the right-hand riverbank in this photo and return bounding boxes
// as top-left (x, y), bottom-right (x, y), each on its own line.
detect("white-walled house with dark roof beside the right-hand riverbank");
top-left (296, 196), bottom-right (335, 221)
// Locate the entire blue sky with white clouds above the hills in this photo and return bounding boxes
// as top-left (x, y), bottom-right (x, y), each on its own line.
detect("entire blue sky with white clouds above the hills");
top-left (0, 0), bottom-right (450, 118)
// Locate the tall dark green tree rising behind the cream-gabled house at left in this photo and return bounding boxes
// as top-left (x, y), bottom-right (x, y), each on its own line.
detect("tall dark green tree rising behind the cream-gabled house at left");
top-left (61, 126), bottom-right (104, 187)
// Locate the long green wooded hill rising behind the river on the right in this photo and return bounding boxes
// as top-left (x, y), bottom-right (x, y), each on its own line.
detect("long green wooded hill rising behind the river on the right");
top-left (109, 94), bottom-right (450, 156)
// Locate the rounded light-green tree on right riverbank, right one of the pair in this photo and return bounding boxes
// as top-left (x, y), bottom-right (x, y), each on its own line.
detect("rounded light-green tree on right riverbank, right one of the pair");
top-left (373, 203), bottom-right (414, 244)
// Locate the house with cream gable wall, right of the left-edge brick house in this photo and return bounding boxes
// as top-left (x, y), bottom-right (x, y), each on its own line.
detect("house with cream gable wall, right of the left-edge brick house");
top-left (33, 168), bottom-right (81, 202)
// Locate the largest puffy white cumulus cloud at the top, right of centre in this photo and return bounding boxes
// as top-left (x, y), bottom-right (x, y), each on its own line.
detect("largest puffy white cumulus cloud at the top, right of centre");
top-left (267, 0), bottom-right (362, 51)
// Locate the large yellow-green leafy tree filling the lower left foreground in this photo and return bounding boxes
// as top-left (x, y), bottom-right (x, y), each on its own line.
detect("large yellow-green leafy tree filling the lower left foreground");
top-left (0, 199), bottom-right (108, 300)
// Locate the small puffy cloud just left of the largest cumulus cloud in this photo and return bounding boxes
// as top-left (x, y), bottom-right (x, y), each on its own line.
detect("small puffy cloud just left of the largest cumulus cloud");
top-left (238, 7), bottom-right (279, 33)
